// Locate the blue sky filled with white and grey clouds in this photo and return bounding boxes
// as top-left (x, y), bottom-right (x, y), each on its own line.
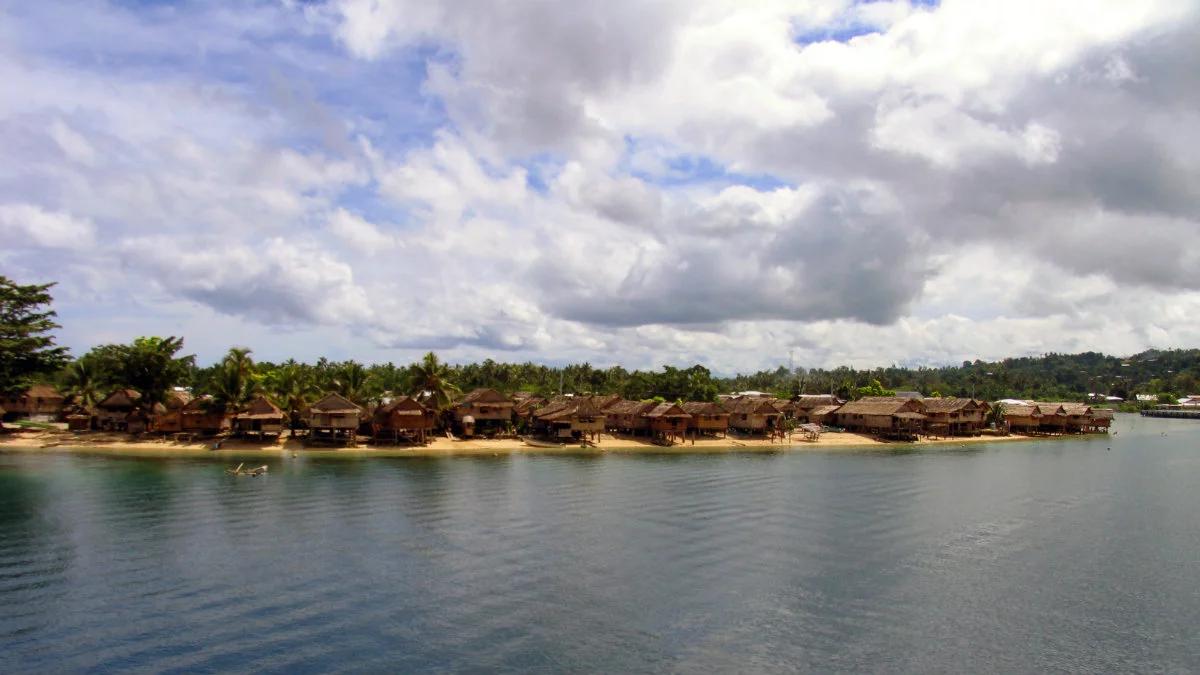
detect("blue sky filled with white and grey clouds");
top-left (0, 0), bottom-right (1200, 374)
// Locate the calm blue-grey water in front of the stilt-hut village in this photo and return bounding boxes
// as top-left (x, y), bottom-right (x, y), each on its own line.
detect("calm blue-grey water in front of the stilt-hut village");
top-left (0, 417), bottom-right (1200, 673)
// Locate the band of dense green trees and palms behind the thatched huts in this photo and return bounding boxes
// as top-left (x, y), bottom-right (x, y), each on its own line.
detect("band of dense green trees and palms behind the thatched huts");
top-left (0, 276), bottom-right (1200, 410)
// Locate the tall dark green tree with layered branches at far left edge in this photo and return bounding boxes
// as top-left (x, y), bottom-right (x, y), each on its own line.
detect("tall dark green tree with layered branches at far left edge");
top-left (0, 276), bottom-right (67, 394)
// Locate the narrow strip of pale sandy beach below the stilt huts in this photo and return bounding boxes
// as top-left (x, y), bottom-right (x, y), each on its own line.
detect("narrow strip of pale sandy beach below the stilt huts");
top-left (0, 430), bottom-right (1056, 459)
